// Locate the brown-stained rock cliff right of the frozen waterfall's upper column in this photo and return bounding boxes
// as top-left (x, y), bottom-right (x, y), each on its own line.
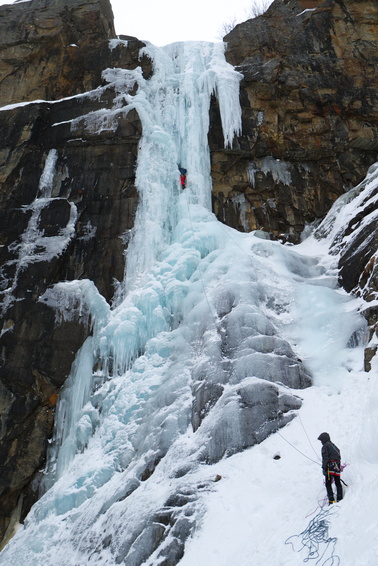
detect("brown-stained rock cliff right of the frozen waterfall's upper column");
top-left (210, 0), bottom-right (378, 241)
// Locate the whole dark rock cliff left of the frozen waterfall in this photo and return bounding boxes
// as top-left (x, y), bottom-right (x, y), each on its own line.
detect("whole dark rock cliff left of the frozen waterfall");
top-left (0, 0), bottom-right (151, 540)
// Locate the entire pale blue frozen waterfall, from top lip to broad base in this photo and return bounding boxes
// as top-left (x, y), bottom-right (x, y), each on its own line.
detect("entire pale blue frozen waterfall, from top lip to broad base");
top-left (0, 43), bottom-right (363, 566)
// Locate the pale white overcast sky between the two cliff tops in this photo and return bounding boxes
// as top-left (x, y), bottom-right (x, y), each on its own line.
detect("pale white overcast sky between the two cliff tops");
top-left (0, 0), bottom-right (268, 45)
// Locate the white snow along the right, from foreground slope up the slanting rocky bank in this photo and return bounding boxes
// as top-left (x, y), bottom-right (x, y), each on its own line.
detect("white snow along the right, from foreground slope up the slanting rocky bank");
top-left (180, 164), bottom-right (378, 566)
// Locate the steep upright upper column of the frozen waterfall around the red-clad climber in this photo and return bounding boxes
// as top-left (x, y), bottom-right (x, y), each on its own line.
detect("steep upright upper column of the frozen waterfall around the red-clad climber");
top-left (126, 42), bottom-right (241, 289)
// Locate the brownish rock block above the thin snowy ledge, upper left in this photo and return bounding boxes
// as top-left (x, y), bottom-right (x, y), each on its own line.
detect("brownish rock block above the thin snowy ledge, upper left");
top-left (0, 0), bottom-right (116, 106)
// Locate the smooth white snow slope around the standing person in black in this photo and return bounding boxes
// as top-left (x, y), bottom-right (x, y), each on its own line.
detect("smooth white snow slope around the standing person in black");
top-left (180, 358), bottom-right (378, 566)
